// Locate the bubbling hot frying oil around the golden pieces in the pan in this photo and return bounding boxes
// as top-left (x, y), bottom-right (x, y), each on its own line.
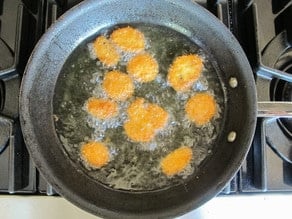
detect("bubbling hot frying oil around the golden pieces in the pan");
top-left (54, 24), bottom-right (224, 191)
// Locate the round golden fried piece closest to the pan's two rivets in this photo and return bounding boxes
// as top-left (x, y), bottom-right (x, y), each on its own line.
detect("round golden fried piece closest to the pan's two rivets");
top-left (185, 93), bottom-right (217, 126)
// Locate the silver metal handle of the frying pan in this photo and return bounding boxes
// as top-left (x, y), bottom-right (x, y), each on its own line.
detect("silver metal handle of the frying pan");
top-left (258, 101), bottom-right (292, 118)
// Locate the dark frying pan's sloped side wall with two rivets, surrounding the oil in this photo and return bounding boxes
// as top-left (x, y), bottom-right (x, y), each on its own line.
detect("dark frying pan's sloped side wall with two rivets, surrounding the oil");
top-left (20, 0), bottom-right (257, 218)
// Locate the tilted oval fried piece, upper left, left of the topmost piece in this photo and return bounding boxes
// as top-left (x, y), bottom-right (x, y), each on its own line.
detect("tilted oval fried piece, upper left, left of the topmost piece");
top-left (93, 36), bottom-right (120, 66)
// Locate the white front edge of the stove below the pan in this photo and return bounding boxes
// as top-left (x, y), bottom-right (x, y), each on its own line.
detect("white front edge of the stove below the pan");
top-left (0, 193), bottom-right (292, 219)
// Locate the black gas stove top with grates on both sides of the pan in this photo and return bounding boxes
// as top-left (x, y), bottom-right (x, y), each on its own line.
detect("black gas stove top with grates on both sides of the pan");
top-left (0, 0), bottom-right (292, 195)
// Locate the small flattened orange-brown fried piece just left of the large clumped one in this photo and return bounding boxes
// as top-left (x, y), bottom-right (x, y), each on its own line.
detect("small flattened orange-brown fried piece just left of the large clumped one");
top-left (86, 97), bottom-right (119, 119)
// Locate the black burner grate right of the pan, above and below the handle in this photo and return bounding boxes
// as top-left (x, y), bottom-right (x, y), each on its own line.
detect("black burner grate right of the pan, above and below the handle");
top-left (240, 0), bottom-right (292, 192)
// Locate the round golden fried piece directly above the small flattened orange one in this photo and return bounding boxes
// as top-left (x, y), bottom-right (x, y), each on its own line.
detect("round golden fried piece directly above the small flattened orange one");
top-left (102, 71), bottom-right (134, 101)
